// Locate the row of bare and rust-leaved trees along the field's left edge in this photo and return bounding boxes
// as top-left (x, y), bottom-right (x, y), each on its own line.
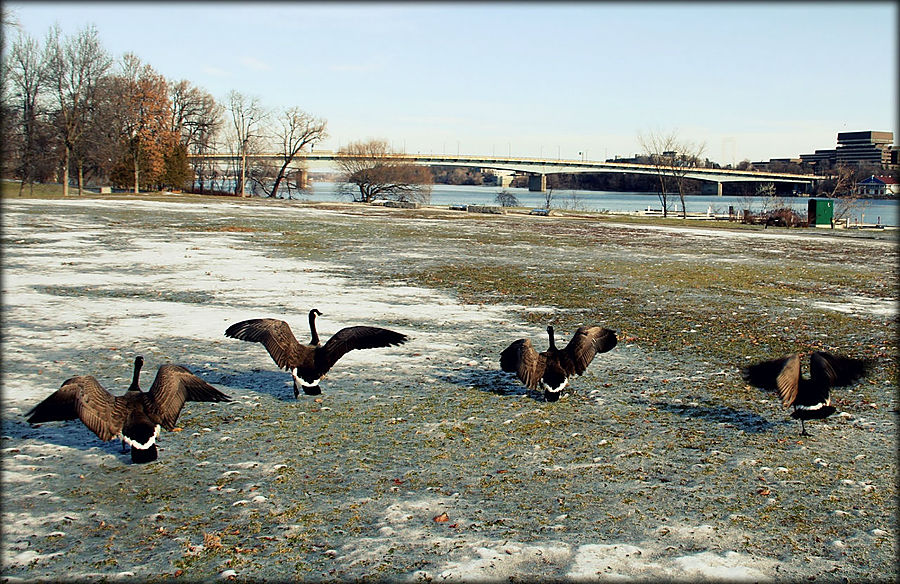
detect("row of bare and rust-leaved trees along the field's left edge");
top-left (0, 20), bottom-right (327, 197)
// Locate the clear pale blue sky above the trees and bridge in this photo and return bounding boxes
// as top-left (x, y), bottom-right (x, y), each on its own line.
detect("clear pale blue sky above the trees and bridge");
top-left (4, 2), bottom-right (898, 164)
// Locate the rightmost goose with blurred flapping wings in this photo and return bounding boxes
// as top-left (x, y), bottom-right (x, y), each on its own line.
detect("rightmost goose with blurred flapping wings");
top-left (741, 351), bottom-right (870, 436)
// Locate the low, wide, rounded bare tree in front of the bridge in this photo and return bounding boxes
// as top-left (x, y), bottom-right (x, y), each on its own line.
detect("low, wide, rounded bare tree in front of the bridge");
top-left (336, 140), bottom-right (433, 203)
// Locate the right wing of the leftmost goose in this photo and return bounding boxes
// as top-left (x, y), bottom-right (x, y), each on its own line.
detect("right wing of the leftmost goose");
top-left (147, 365), bottom-right (231, 430)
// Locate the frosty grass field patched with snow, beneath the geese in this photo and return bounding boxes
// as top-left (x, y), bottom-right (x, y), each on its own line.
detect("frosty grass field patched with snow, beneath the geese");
top-left (2, 197), bottom-right (898, 581)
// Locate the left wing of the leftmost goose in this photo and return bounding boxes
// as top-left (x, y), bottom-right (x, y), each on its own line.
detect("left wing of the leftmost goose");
top-left (26, 375), bottom-right (127, 440)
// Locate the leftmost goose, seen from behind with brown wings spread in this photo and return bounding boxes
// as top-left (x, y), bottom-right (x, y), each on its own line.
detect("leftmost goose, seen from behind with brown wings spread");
top-left (25, 356), bottom-right (231, 463)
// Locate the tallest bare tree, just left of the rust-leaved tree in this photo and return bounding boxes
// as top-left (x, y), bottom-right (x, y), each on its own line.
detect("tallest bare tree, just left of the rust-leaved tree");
top-left (46, 24), bottom-right (112, 196)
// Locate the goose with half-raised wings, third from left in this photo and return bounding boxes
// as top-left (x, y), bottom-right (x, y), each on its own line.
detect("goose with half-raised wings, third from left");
top-left (500, 326), bottom-right (618, 402)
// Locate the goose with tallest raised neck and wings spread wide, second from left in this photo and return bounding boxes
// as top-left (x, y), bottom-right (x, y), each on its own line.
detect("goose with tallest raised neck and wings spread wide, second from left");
top-left (225, 308), bottom-right (409, 397)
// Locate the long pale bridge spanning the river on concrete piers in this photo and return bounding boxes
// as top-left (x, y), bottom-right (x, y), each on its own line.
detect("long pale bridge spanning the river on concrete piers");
top-left (188, 151), bottom-right (826, 195)
